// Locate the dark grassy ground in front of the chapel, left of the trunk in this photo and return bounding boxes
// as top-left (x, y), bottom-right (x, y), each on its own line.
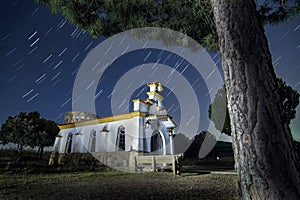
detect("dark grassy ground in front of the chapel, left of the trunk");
top-left (0, 152), bottom-right (237, 200)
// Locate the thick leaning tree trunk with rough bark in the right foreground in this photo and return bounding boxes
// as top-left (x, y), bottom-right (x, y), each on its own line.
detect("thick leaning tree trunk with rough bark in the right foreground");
top-left (211, 0), bottom-right (300, 200)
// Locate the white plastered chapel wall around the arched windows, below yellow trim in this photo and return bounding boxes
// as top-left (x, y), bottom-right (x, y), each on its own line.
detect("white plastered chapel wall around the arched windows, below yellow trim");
top-left (52, 117), bottom-right (171, 154)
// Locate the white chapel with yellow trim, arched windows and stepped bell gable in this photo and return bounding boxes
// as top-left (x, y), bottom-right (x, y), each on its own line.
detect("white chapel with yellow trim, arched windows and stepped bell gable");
top-left (50, 82), bottom-right (176, 164)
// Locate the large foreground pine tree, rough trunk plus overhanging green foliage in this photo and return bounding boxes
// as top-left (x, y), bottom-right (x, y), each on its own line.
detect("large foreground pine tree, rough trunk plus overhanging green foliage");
top-left (38, 0), bottom-right (300, 199)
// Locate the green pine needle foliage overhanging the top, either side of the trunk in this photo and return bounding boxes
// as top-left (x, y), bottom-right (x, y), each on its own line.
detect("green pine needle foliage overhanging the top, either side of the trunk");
top-left (36, 0), bottom-right (300, 50)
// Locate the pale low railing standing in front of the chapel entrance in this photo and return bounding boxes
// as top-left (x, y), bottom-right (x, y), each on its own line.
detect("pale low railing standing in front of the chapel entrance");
top-left (134, 155), bottom-right (179, 175)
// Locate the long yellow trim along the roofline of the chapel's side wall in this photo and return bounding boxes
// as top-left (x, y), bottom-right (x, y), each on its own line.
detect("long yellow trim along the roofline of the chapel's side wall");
top-left (58, 111), bottom-right (146, 130)
